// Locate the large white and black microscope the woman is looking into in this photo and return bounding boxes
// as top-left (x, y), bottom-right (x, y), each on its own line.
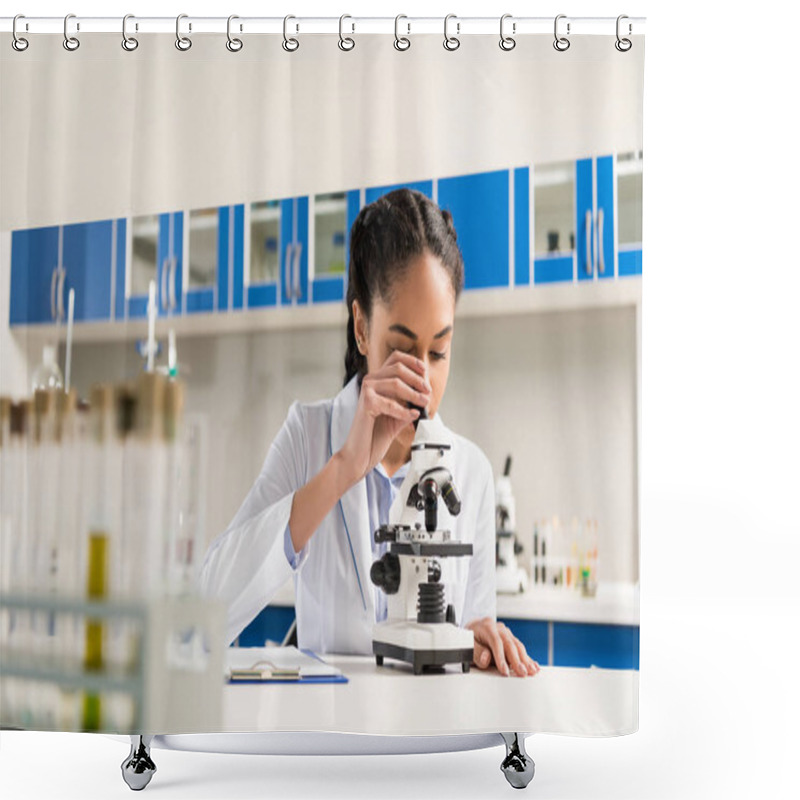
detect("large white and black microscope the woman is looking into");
top-left (370, 409), bottom-right (475, 675)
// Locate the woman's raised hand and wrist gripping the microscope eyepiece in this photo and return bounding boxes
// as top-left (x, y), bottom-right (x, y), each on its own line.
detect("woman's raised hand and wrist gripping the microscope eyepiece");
top-left (340, 350), bottom-right (431, 483)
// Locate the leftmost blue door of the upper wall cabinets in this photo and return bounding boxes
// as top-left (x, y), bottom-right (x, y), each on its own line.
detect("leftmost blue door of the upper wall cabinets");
top-left (9, 226), bottom-right (59, 325)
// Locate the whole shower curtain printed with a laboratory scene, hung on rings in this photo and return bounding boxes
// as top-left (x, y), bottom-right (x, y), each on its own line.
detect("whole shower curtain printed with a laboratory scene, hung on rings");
top-left (0, 15), bottom-right (644, 736)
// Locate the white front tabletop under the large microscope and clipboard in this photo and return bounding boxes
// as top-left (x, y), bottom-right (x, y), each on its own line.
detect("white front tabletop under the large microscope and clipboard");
top-left (214, 654), bottom-right (639, 736)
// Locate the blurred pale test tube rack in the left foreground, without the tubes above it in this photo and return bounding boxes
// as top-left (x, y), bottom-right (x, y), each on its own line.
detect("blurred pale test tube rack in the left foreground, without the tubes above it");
top-left (0, 594), bottom-right (225, 735)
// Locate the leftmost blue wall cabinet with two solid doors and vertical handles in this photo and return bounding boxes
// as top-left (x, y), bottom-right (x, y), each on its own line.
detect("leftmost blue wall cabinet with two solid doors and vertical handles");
top-left (9, 220), bottom-right (118, 325)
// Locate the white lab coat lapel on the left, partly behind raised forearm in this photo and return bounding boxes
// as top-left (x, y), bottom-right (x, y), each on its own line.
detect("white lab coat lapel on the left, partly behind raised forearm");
top-left (331, 376), bottom-right (375, 620)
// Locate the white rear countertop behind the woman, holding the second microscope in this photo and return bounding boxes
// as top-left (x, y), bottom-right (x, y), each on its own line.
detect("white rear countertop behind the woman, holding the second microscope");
top-left (272, 580), bottom-right (639, 625)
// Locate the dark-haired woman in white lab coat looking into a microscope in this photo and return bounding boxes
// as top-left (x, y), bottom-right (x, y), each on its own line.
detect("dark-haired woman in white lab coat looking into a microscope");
top-left (200, 189), bottom-right (539, 676)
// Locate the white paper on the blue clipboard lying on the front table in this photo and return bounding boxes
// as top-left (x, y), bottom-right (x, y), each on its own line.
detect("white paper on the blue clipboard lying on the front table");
top-left (225, 646), bottom-right (342, 681)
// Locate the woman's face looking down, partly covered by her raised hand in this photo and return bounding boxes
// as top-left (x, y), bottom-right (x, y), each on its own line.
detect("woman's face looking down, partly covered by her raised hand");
top-left (354, 250), bottom-right (455, 446)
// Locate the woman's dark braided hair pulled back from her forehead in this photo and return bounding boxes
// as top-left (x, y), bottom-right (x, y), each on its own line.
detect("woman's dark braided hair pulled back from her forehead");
top-left (344, 188), bottom-right (464, 386)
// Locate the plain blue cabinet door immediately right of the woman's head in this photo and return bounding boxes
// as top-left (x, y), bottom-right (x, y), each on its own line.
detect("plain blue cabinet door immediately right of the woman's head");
top-left (437, 170), bottom-right (511, 289)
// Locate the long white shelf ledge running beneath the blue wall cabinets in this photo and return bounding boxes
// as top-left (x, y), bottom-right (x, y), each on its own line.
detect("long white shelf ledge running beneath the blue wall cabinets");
top-left (11, 277), bottom-right (642, 342)
